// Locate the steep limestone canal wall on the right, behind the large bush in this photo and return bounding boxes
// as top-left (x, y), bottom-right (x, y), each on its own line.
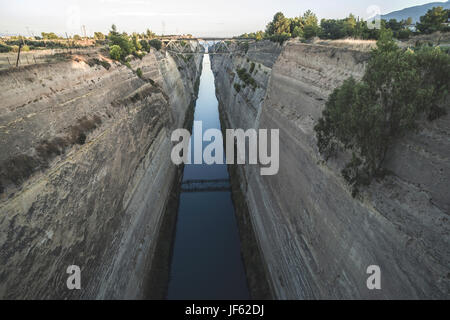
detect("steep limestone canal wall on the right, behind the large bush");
top-left (211, 41), bottom-right (450, 299)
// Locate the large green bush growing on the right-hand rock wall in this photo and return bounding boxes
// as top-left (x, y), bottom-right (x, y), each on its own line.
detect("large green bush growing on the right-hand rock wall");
top-left (315, 30), bottom-right (450, 195)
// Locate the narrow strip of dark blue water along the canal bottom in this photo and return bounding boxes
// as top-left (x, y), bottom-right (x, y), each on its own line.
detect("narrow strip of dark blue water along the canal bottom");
top-left (167, 55), bottom-right (249, 300)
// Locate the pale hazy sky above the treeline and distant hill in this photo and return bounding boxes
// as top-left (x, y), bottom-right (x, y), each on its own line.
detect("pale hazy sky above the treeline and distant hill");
top-left (0, 0), bottom-right (445, 36)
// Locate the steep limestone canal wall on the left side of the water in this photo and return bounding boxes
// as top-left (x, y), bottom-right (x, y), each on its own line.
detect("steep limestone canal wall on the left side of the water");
top-left (0, 42), bottom-right (203, 299)
